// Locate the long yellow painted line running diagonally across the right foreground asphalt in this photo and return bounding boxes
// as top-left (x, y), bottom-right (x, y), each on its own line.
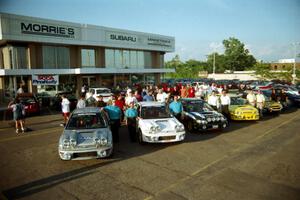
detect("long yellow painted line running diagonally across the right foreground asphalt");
top-left (144, 111), bottom-right (300, 200)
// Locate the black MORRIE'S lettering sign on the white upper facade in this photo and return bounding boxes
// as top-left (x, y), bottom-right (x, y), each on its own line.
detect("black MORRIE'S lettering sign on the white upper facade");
top-left (20, 22), bottom-right (75, 38)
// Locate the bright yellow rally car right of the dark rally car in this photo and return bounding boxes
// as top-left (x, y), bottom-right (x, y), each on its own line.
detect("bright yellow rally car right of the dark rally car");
top-left (229, 96), bottom-right (259, 120)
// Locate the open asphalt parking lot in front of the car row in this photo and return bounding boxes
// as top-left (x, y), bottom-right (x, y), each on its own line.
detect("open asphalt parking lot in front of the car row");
top-left (0, 109), bottom-right (300, 200)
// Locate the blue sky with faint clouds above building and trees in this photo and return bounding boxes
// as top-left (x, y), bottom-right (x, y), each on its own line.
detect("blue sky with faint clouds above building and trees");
top-left (0, 0), bottom-right (300, 62)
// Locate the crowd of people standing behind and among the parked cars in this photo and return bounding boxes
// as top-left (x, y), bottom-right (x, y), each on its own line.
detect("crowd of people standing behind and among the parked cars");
top-left (8, 82), bottom-right (287, 137)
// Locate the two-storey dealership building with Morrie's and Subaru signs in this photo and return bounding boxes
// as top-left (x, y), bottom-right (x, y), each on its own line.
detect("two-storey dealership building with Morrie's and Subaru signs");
top-left (0, 13), bottom-right (175, 100)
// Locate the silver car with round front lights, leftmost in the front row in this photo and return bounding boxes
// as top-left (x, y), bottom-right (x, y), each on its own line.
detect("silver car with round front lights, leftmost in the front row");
top-left (58, 107), bottom-right (113, 160)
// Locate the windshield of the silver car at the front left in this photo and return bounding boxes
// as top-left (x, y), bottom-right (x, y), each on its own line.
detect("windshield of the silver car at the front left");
top-left (66, 113), bottom-right (107, 130)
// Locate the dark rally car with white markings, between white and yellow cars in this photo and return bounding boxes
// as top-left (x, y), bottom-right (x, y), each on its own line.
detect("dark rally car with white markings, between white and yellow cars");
top-left (180, 98), bottom-right (228, 132)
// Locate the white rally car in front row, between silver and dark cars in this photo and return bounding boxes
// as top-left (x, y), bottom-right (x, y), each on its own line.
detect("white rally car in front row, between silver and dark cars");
top-left (137, 102), bottom-right (185, 143)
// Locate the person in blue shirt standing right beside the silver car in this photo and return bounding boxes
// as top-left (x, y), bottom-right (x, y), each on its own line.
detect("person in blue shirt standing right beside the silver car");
top-left (103, 100), bottom-right (122, 143)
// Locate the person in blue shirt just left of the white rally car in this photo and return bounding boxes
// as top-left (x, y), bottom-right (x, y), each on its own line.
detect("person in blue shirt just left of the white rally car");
top-left (125, 101), bottom-right (138, 142)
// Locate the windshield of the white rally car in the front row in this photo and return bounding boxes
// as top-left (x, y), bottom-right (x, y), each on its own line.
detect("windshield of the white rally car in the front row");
top-left (141, 106), bottom-right (170, 119)
